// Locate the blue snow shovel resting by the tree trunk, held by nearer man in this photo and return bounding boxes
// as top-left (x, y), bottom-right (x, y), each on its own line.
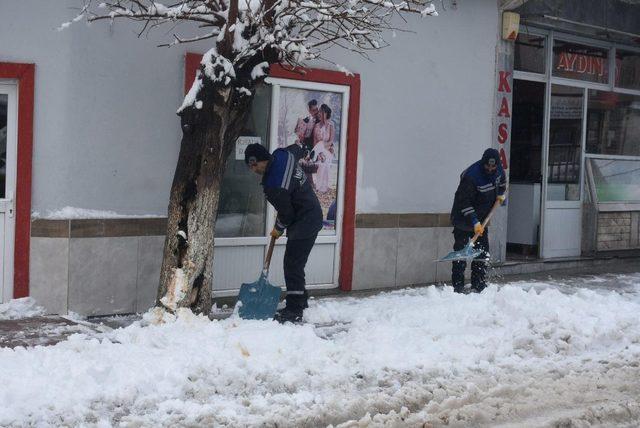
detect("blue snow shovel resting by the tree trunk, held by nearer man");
top-left (238, 236), bottom-right (281, 320)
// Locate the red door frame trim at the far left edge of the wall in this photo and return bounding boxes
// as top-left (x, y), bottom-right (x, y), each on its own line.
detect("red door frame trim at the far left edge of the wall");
top-left (0, 62), bottom-right (36, 299)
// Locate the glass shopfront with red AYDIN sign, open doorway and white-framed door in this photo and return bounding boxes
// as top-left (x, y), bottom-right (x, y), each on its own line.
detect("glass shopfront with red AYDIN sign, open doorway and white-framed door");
top-left (507, 29), bottom-right (640, 259)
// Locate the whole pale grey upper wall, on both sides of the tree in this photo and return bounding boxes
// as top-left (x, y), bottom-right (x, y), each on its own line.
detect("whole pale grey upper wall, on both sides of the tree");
top-left (0, 0), bottom-right (499, 214)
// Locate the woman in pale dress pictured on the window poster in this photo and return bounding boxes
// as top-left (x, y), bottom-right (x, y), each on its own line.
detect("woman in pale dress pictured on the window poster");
top-left (313, 104), bottom-right (336, 193)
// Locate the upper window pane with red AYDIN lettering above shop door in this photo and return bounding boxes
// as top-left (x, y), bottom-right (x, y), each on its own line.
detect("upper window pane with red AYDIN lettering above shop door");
top-left (553, 40), bottom-right (609, 83)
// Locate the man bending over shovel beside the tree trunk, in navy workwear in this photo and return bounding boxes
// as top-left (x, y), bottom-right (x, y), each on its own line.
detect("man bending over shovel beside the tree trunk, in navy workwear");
top-left (244, 144), bottom-right (322, 323)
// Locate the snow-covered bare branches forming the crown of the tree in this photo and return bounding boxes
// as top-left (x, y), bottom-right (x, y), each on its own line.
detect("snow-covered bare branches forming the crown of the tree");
top-left (72, 0), bottom-right (437, 110)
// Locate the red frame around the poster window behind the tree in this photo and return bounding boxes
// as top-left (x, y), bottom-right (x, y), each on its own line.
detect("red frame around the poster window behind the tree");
top-left (184, 53), bottom-right (360, 291)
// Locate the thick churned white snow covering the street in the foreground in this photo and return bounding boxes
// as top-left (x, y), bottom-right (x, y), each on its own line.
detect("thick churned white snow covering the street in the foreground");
top-left (0, 274), bottom-right (640, 427)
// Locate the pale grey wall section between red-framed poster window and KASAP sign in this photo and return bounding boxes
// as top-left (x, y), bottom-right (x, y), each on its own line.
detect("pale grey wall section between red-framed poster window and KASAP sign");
top-left (336, 0), bottom-right (499, 213)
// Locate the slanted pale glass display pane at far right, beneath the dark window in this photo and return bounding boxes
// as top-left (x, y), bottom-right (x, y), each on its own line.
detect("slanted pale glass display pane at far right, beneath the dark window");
top-left (589, 158), bottom-right (640, 203)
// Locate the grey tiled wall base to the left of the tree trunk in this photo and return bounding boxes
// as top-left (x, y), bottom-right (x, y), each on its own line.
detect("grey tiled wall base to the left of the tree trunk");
top-left (30, 236), bottom-right (164, 316)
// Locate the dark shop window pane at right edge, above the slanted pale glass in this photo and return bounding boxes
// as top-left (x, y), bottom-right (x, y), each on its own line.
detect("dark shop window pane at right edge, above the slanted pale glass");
top-left (586, 90), bottom-right (640, 156)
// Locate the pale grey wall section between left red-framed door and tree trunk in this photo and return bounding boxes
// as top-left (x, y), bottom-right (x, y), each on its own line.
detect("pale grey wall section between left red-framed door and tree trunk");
top-left (0, 0), bottom-right (210, 215)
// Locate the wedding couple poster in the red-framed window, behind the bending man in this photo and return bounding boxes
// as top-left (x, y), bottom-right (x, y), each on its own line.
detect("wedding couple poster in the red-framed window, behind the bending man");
top-left (278, 87), bottom-right (343, 235)
